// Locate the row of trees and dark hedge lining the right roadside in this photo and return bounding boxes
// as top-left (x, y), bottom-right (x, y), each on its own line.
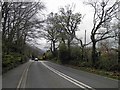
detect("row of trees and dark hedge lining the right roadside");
top-left (42, 0), bottom-right (120, 72)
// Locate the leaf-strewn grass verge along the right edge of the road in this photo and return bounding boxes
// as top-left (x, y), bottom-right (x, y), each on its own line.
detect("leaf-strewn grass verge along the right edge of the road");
top-left (50, 59), bottom-right (120, 80)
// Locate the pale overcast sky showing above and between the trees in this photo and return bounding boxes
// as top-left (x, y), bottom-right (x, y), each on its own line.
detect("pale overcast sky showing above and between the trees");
top-left (34, 0), bottom-right (93, 49)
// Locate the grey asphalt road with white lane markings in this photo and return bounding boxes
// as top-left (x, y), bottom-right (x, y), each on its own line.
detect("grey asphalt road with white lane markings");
top-left (2, 61), bottom-right (119, 90)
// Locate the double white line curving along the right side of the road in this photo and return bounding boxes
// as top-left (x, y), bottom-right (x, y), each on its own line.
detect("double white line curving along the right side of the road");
top-left (41, 61), bottom-right (95, 90)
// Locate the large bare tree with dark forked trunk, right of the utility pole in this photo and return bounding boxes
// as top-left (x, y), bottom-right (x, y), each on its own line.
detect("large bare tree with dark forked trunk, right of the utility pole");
top-left (87, 0), bottom-right (119, 66)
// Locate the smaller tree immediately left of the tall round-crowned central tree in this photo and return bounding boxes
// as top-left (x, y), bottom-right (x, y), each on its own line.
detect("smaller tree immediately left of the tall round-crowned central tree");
top-left (41, 12), bottom-right (59, 56)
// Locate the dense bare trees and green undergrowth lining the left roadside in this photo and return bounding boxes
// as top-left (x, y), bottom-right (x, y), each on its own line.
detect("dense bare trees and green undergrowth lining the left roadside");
top-left (1, 2), bottom-right (44, 72)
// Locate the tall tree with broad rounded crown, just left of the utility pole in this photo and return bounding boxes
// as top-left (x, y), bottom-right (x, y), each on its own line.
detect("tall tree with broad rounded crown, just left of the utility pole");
top-left (58, 5), bottom-right (81, 56)
